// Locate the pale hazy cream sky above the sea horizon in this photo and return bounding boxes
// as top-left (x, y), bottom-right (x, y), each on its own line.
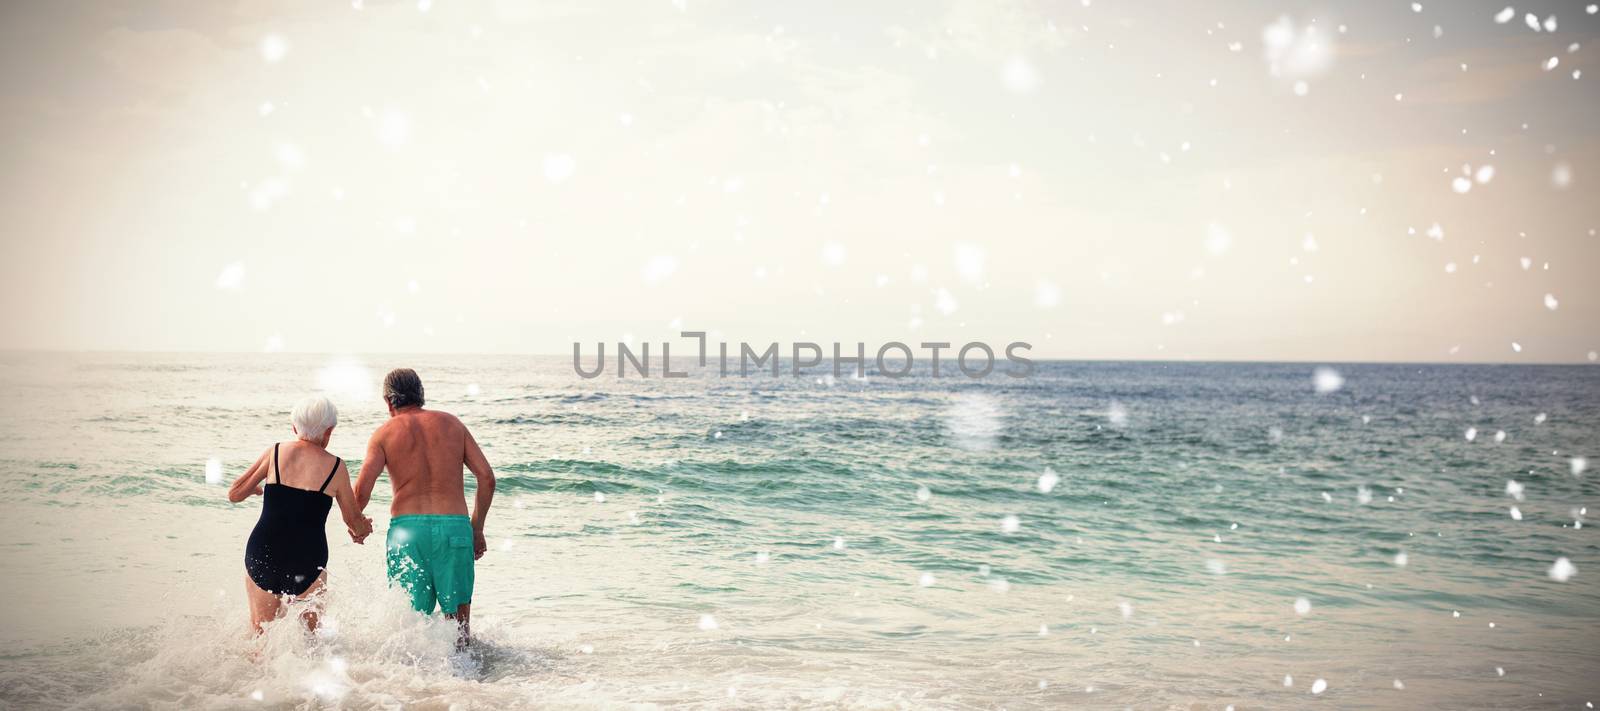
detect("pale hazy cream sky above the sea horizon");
top-left (0, 0), bottom-right (1600, 364)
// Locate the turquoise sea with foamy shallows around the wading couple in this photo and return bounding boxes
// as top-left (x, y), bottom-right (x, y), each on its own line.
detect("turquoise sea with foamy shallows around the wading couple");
top-left (0, 354), bottom-right (1600, 708)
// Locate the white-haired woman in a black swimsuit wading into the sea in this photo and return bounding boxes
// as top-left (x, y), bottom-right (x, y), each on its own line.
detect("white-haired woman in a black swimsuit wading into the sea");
top-left (227, 397), bottom-right (373, 633)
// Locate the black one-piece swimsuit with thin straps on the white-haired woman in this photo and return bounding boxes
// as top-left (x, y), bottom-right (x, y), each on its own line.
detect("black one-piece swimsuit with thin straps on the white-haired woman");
top-left (245, 445), bottom-right (342, 596)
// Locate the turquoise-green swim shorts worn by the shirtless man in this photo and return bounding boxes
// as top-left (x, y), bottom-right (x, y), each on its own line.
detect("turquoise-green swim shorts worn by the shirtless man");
top-left (389, 514), bottom-right (474, 615)
